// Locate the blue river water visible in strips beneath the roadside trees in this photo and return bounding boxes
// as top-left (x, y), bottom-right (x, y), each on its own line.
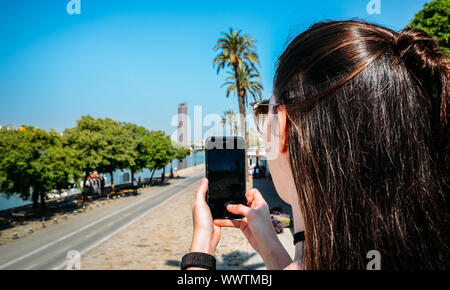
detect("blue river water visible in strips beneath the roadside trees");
top-left (0, 151), bottom-right (205, 210)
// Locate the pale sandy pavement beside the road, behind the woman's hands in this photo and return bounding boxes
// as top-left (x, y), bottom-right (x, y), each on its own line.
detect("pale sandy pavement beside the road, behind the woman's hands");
top-left (81, 169), bottom-right (292, 270)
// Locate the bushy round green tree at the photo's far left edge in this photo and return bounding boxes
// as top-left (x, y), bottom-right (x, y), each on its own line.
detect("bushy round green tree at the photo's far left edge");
top-left (0, 126), bottom-right (81, 211)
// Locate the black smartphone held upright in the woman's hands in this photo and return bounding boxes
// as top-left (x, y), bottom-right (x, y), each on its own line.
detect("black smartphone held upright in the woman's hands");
top-left (205, 136), bottom-right (246, 219)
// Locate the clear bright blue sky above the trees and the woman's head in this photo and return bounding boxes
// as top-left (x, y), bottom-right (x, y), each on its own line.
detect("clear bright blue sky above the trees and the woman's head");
top-left (0, 0), bottom-right (427, 140)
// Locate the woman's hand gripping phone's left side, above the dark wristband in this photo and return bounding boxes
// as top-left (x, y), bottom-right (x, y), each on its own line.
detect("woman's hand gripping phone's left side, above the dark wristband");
top-left (190, 178), bottom-right (220, 255)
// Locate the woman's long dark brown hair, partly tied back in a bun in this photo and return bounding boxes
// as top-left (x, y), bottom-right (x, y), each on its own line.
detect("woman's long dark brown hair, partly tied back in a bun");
top-left (274, 21), bottom-right (450, 269)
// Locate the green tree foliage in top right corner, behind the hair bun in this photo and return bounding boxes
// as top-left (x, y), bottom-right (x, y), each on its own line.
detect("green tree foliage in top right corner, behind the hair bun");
top-left (409, 0), bottom-right (450, 57)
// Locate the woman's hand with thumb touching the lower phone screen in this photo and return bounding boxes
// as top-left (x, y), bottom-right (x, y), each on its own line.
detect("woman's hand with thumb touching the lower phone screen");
top-left (214, 189), bottom-right (281, 259)
